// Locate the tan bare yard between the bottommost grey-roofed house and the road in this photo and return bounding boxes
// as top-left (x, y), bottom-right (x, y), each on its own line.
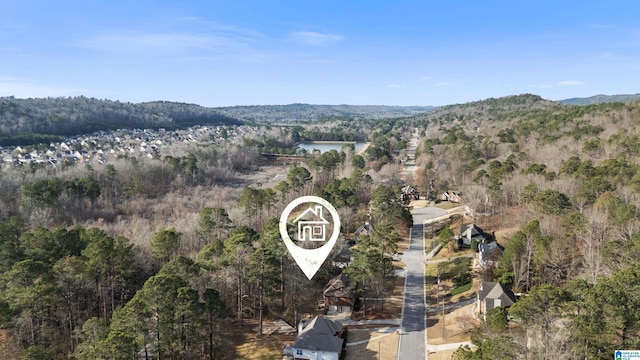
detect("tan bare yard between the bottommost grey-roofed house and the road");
top-left (344, 327), bottom-right (398, 360)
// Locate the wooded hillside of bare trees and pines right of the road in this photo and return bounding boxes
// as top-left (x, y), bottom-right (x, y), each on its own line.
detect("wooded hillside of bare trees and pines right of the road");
top-left (400, 95), bottom-right (640, 359)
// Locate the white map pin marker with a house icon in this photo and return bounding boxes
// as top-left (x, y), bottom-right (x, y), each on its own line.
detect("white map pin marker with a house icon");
top-left (280, 196), bottom-right (340, 280)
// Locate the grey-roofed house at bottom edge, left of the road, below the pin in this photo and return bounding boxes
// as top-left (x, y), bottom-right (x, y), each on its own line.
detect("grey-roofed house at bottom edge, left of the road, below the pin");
top-left (291, 316), bottom-right (344, 360)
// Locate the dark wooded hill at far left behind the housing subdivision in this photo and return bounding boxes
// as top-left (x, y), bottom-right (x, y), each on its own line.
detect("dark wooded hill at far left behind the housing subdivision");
top-left (0, 96), bottom-right (241, 140)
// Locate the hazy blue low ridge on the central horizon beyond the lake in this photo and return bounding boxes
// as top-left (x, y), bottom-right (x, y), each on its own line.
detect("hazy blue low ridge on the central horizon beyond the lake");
top-left (216, 104), bottom-right (435, 123)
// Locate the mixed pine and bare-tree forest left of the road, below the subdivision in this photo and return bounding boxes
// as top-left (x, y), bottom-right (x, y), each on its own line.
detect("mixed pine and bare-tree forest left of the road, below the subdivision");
top-left (0, 108), bottom-right (411, 359)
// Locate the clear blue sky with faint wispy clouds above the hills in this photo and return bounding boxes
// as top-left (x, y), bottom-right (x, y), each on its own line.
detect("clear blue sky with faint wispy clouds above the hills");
top-left (0, 0), bottom-right (640, 106)
